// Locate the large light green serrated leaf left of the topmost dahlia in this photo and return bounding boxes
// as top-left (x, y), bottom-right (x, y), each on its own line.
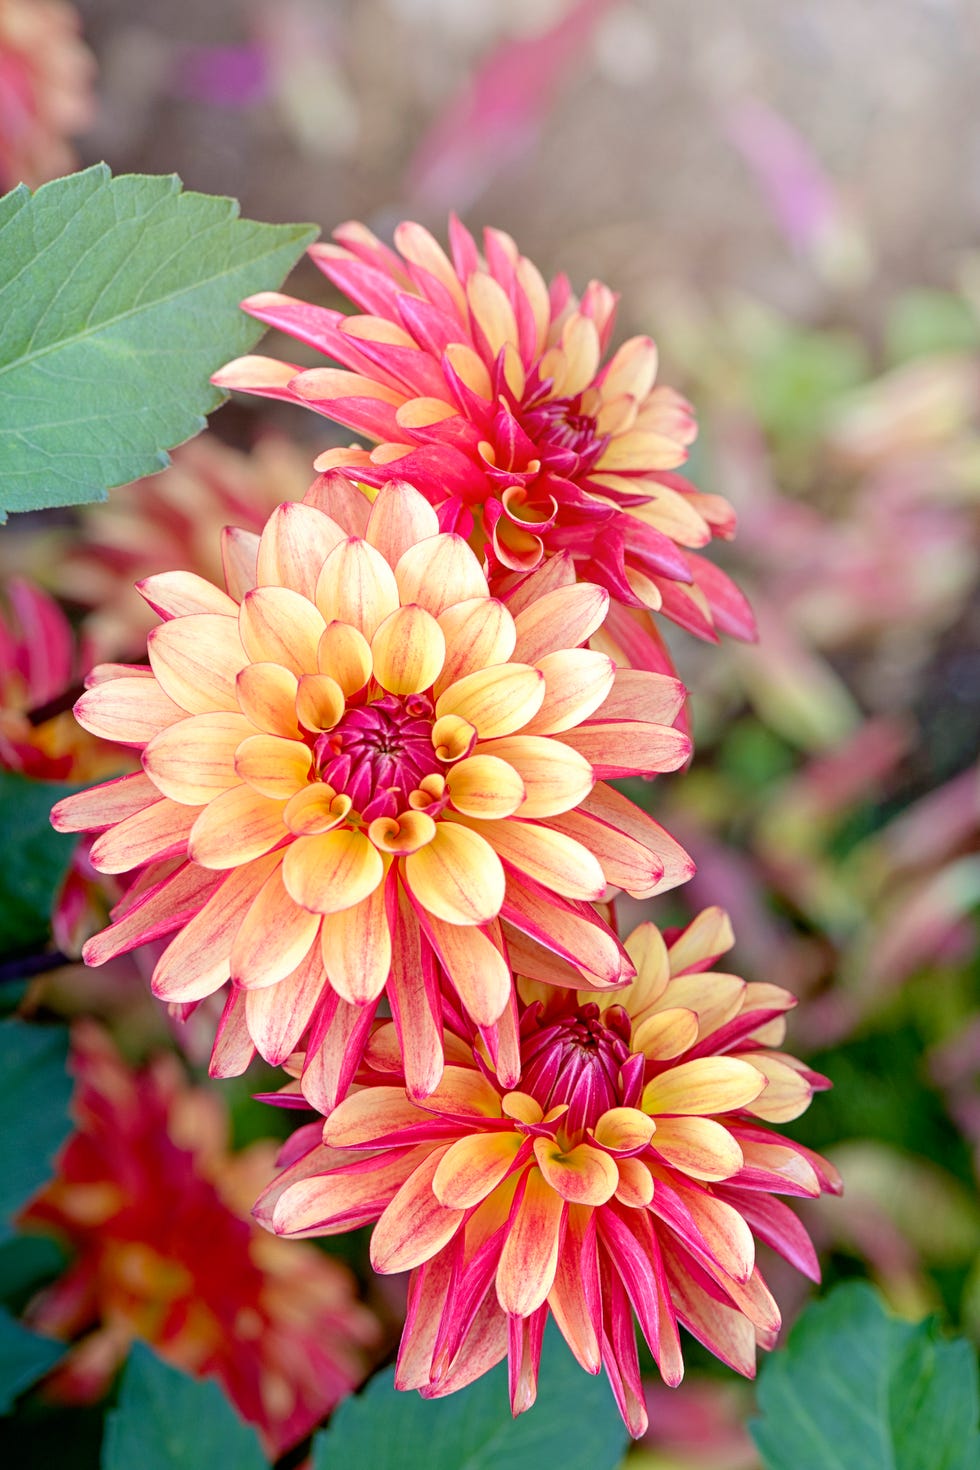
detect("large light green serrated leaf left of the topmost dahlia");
top-left (0, 163), bottom-right (316, 519)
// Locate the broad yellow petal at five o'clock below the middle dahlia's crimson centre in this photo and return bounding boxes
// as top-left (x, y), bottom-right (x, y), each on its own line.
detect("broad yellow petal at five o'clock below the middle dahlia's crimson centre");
top-left (404, 822), bottom-right (504, 923)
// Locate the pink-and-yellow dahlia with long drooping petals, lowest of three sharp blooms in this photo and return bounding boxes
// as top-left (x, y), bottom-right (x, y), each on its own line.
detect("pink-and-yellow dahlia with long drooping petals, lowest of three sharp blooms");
top-left (257, 908), bottom-right (839, 1435)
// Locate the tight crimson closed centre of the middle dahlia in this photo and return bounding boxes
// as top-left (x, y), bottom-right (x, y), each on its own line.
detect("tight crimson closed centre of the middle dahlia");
top-left (313, 694), bottom-right (442, 822)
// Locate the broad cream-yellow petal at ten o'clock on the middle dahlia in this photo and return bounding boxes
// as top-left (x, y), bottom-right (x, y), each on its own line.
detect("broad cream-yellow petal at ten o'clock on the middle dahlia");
top-left (147, 613), bottom-right (248, 714)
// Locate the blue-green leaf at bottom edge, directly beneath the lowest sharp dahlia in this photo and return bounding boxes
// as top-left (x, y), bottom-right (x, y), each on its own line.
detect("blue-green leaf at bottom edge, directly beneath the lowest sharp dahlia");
top-left (313, 1333), bottom-right (626, 1470)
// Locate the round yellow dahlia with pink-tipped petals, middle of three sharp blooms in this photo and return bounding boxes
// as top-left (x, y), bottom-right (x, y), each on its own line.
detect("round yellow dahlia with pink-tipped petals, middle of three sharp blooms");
top-left (53, 473), bottom-right (691, 1107)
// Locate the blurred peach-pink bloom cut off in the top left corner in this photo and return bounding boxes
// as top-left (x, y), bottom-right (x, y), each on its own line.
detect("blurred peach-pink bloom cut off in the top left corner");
top-left (0, 0), bottom-right (96, 194)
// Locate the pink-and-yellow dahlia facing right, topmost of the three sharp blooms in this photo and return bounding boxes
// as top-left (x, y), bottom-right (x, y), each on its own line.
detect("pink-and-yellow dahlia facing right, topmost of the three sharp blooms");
top-left (215, 218), bottom-right (754, 669)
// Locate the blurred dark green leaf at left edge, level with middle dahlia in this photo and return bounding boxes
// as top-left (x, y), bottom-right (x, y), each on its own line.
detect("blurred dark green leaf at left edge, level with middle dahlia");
top-left (0, 770), bottom-right (78, 957)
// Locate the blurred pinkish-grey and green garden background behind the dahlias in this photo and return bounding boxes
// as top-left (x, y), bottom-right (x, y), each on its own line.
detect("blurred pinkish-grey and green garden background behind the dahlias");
top-left (4, 0), bottom-right (980, 1470)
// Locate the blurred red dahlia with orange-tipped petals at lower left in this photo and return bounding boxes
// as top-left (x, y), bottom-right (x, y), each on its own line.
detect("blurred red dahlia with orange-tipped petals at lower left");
top-left (21, 1023), bottom-right (381, 1455)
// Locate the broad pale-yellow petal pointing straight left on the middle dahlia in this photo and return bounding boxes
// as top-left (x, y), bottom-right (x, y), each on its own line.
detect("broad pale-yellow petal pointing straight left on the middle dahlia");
top-left (143, 708), bottom-right (254, 807)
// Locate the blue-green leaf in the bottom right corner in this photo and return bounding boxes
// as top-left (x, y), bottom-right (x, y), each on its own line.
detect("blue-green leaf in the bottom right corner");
top-left (749, 1282), bottom-right (980, 1470)
